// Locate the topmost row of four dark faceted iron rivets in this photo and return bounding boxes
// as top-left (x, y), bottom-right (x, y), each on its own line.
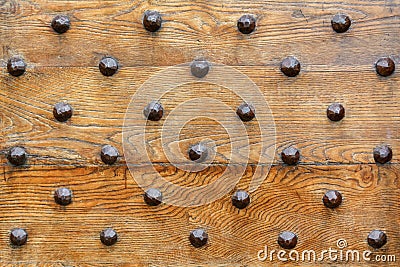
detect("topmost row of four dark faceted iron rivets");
top-left (47, 10), bottom-right (351, 34)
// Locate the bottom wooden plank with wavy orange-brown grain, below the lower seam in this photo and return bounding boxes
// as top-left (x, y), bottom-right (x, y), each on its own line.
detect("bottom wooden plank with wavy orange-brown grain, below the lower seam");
top-left (0, 164), bottom-right (400, 266)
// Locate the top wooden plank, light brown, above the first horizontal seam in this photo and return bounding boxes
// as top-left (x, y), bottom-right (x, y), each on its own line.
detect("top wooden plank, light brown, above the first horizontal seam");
top-left (0, 0), bottom-right (400, 67)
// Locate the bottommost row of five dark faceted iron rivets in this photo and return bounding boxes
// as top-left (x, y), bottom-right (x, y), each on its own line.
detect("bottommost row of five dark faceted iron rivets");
top-left (10, 228), bottom-right (387, 249)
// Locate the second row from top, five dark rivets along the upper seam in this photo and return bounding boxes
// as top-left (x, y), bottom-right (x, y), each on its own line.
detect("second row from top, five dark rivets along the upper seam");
top-left (7, 56), bottom-right (395, 78)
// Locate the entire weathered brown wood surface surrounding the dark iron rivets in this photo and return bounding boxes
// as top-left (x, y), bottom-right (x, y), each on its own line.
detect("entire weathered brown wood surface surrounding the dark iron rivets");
top-left (0, 0), bottom-right (400, 266)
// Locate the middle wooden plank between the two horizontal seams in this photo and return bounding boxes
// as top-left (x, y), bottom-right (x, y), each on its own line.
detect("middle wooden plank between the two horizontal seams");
top-left (0, 66), bottom-right (400, 165)
